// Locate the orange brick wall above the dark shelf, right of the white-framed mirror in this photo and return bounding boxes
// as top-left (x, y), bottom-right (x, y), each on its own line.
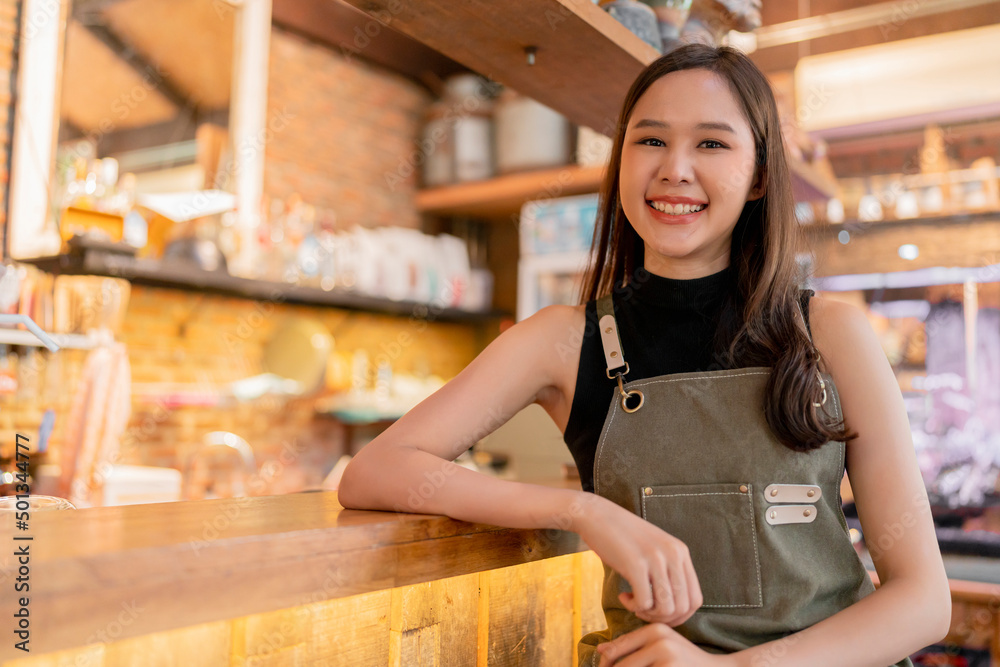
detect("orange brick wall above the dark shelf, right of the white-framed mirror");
top-left (264, 26), bottom-right (431, 228)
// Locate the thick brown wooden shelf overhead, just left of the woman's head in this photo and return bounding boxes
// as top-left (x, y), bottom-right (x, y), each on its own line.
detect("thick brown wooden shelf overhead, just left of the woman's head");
top-left (338, 0), bottom-right (660, 134)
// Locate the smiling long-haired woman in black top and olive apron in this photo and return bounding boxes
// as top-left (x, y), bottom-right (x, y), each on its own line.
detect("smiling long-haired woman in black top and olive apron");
top-left (340, 45), bottom-right (950, 667)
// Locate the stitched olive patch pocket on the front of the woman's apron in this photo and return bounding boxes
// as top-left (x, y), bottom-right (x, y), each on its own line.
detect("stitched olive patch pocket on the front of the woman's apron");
top-left (639, 484), bottom-right (764, 608)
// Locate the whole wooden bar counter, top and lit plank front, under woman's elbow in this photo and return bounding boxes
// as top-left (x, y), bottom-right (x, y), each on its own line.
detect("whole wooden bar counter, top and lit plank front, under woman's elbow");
top-left (0, 483), bottom-right (604, 666)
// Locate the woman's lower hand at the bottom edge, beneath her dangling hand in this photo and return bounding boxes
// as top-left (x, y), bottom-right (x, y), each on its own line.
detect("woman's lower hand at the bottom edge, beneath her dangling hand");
top-left (597, 623), bottom-right (730, 667)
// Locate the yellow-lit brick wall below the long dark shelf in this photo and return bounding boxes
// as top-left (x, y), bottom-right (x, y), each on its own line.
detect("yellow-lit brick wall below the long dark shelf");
top-left (0, 286), bottom-right (479, 500)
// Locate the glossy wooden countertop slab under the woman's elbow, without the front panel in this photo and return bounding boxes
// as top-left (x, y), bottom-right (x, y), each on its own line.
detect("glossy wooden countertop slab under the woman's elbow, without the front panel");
top-left (0, 480), bottom-right (587, 661)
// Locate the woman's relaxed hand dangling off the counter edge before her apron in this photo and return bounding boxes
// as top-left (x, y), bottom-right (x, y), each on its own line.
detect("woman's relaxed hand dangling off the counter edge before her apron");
top-left (574, 494), bottom-right (702, 626)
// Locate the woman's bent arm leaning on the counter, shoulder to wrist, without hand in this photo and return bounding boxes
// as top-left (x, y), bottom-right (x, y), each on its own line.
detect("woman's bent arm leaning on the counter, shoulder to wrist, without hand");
top-left (338, 306), bottom-right (596, 530)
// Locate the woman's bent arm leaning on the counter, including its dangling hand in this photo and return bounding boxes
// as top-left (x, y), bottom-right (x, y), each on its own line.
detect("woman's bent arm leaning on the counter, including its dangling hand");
top-left (339, 306), bottom-right (702, 625)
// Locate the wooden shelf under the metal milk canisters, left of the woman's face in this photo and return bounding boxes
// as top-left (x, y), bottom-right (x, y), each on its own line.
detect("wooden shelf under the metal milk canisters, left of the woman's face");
top-left (417, 165), bottom-right (604, 218)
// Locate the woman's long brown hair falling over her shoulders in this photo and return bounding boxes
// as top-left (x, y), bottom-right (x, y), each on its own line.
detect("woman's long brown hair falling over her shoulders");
top-left (581, 44), bottom-right (855, 451)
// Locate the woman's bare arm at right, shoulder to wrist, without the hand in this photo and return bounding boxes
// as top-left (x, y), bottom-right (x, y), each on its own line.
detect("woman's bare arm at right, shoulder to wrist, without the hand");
top-left (731, 299), bottom-right (951, 667)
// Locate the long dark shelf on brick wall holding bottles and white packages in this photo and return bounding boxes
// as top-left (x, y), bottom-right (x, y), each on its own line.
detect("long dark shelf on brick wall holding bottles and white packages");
top-left (20, 251), bottom-right (511, 323)
